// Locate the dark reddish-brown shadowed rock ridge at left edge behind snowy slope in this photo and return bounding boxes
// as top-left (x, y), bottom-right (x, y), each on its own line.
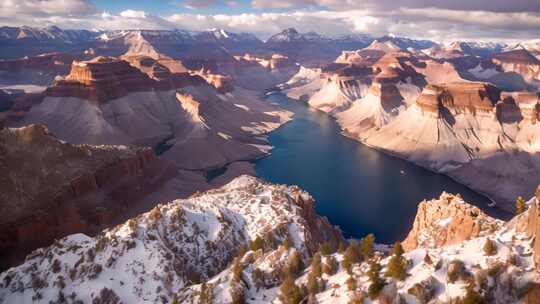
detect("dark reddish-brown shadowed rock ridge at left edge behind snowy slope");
top-left (0, 125), bottom-right (173, 268)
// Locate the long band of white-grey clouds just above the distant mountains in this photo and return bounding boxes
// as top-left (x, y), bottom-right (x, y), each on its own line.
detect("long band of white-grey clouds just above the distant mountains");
top-left (0, 0), bottom-right (540, 42)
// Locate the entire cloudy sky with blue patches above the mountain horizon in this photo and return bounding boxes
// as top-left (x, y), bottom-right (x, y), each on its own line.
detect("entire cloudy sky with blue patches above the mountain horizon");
top-left (0, 0), bottom-right (540, 42)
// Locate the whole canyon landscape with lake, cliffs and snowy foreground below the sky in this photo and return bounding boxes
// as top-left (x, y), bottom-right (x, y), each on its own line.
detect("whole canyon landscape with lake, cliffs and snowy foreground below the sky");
top-left (0, 26), bottom-right (540, 304)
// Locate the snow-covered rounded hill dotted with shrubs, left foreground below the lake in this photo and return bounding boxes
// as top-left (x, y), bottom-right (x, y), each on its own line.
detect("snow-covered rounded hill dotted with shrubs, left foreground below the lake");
top-left (0, 176), bottom-right (339, 303)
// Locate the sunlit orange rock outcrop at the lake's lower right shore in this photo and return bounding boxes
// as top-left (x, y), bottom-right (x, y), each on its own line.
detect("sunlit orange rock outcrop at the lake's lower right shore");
top-left (402, 193), bottom-right (503, 251)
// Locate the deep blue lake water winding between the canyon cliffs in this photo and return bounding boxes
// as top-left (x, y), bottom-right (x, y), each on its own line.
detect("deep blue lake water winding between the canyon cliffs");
top-left (255, 93), bottom-right (508, 243)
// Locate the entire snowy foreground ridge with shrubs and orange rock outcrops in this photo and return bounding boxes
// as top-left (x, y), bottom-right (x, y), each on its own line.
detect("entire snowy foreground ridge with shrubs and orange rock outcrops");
top-left (0, 176), bottom-right (540, 304)
